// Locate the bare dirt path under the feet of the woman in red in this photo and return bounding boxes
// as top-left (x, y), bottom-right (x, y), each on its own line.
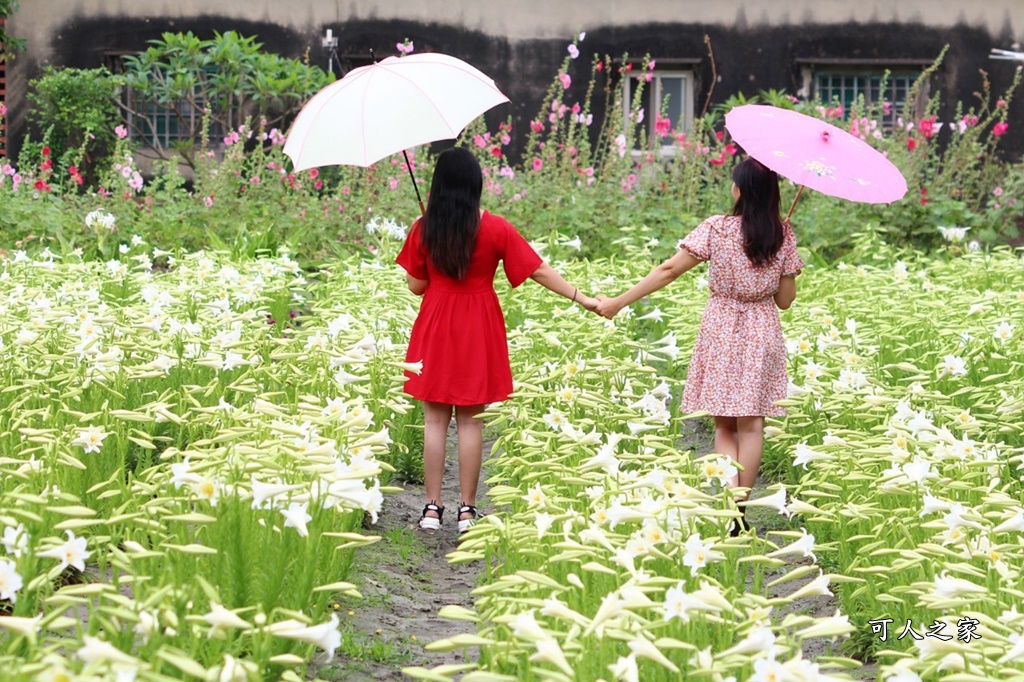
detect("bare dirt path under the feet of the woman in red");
top-left (316, 424), bottom-right (493, 681)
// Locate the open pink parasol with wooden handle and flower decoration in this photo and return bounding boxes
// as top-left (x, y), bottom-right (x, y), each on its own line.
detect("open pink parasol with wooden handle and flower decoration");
top-left (725, 104), bottom-right (906, 214)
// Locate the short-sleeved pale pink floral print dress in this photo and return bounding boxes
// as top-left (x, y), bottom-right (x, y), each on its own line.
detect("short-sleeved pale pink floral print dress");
top-left (681, 215), bottom-right (805, 417)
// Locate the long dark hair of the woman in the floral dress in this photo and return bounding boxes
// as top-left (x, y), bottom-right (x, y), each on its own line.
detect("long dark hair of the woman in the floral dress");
top-left (732, 158), bottom-right (785, 267)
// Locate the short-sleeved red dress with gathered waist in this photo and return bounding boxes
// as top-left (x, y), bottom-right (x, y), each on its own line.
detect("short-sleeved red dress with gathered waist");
top-left (395, 211), bottom-right (544, 406)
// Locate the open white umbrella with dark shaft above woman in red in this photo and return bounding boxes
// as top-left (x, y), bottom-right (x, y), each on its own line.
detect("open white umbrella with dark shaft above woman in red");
top-left (285, 52), bottom-right (509, 210)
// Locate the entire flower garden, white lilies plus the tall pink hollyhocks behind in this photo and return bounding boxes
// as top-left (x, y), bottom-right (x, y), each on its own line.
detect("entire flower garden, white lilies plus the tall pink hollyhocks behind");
top-left (0, 33), bottom-right (1024, 682)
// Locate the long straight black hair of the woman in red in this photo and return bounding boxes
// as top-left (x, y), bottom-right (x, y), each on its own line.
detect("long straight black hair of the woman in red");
top-left (423, 146), bottom-right (483, 280)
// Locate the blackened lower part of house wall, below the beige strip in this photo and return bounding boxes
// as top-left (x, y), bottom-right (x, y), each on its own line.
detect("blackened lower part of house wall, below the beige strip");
top-left (8, 16), bottom-right (1024, 158)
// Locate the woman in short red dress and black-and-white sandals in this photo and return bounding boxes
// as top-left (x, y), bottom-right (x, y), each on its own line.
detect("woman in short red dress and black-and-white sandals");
top-left (396, 147), bottom-right (597, 532)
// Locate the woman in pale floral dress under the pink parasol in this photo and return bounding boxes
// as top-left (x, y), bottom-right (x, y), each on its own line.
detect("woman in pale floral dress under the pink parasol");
top-left (597, 159), bottom-right (804, 532)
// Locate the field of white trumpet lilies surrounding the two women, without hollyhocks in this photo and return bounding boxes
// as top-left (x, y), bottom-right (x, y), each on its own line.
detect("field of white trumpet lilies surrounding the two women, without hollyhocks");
top-left (0, 216), bottom-right (1024, 682)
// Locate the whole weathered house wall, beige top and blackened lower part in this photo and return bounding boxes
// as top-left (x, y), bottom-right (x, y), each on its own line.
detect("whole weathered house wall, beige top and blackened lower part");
top-left (7, 0), bottom-right (1024, 155)
